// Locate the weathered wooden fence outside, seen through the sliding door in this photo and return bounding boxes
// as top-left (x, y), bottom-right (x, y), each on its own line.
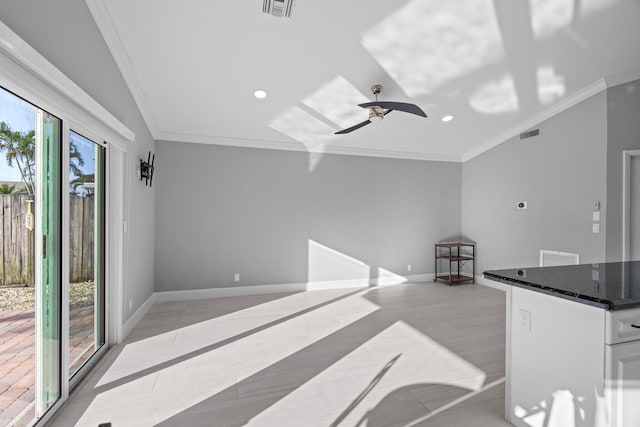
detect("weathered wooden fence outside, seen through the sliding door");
top-left (0, 194), bottom-right (95, 286)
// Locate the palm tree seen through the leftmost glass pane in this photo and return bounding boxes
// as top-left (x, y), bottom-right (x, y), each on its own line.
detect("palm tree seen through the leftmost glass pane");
top-left (0, 122), bottom-right (36, 195)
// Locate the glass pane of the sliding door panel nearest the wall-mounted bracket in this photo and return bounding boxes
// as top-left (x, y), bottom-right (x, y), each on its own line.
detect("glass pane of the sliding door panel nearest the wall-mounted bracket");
top-left (69, 131), bottom-right (105, 377)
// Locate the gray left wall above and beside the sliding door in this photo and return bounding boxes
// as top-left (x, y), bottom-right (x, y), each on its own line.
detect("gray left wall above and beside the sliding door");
top-left (0, 0), bottom-right (155, 320)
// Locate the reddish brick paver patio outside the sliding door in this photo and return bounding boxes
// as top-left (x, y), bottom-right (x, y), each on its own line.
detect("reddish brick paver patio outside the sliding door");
top-left (0, 305), bottom-right (94, 427)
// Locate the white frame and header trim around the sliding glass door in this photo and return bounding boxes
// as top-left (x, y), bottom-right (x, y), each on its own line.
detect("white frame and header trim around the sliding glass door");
top-left (0, 22), bottom-right (135, 425)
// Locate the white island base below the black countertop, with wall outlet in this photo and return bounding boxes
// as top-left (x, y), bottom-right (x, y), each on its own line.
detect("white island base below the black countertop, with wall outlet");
top-left (505, 287), bottom-right (640, 427)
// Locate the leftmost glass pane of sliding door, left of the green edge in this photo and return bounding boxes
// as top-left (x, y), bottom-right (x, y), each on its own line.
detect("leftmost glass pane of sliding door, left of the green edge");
top-left (0, 88), bottom-right (36, 425)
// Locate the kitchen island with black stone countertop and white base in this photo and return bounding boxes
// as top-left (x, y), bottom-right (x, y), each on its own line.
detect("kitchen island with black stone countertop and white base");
top-left (484, 261), bottom-right (640, 427)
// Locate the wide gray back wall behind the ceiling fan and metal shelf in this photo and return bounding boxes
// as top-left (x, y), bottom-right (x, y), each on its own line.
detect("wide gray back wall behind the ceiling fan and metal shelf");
top-left (154, 141), bottom-right (461, 291)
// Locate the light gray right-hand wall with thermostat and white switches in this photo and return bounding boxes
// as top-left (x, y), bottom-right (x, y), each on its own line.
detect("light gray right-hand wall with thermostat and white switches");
top-left (462, 92), bottom-right (607, 271)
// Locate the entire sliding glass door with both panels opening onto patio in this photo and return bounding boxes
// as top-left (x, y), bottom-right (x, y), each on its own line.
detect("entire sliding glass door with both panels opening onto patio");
top-left (0, 83), bottom-right (106, 425)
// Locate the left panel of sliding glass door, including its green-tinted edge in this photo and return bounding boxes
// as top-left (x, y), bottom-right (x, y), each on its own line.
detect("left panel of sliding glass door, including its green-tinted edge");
top-left (0, 88), bottom-right (63, 425)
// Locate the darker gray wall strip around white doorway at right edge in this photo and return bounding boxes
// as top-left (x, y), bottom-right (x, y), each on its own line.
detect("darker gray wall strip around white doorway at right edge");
top-left (607, 80), bottom-right (640, 261)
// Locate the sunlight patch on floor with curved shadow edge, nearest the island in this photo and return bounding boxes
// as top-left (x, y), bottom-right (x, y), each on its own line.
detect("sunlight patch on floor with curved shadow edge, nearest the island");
top-left (249, 321), bottom-right (486, 426)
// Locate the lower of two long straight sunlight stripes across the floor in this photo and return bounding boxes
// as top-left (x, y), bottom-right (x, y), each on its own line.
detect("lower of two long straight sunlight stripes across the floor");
top-left (78, 291), bottom-right (379, 425)
